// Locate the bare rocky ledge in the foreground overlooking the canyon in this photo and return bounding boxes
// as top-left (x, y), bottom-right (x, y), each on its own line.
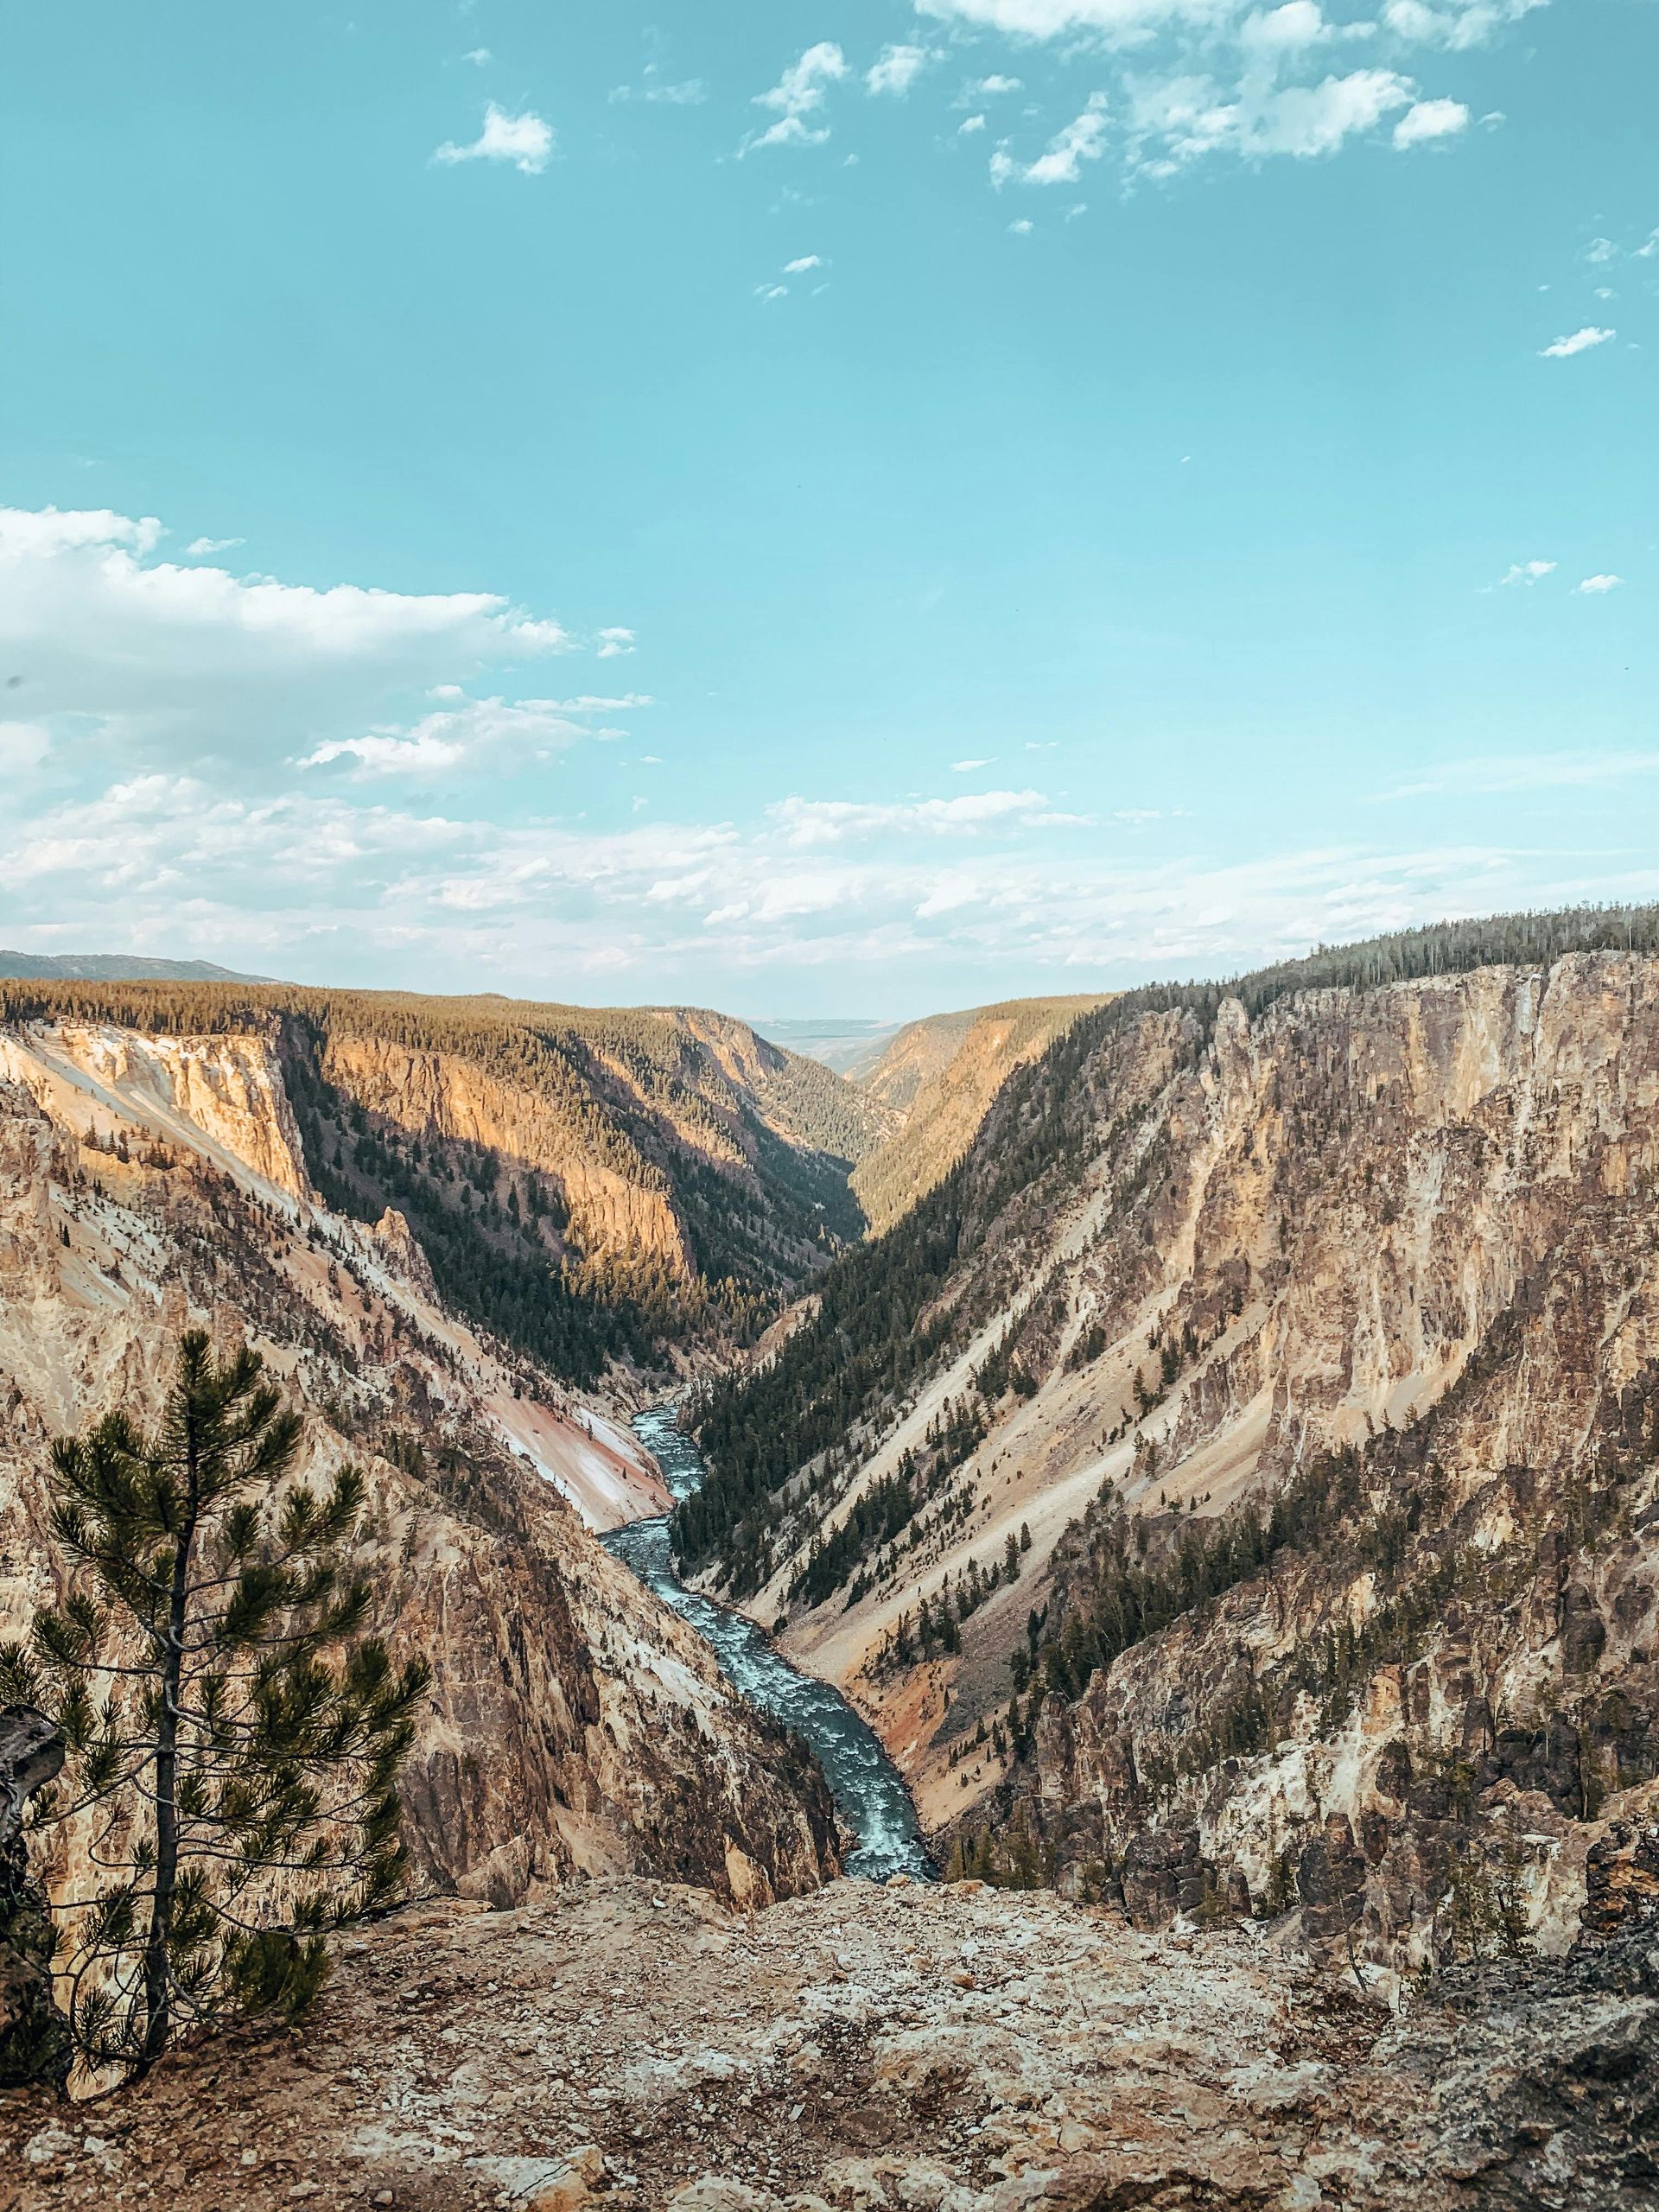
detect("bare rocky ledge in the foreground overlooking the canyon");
top-left (0, 1880), bottom-right (1659, 2212)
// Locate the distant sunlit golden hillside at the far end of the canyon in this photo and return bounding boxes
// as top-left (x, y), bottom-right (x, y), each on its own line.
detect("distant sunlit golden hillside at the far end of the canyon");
top-left (842, 998), bottom-right (1103, 1230)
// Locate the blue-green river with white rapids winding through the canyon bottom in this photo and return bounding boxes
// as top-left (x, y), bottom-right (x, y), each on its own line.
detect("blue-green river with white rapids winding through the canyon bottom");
top-left (604, 1409), bottom-right (933, 1883)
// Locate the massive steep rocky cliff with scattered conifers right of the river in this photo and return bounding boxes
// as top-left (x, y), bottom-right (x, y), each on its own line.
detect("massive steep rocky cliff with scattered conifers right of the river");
top-left (686, 915), bottom-right (1659, 1988)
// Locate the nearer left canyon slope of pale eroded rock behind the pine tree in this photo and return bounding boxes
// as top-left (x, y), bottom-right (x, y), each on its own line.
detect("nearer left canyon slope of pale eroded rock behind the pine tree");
top-left (0, 1024), bottom-right (838, 1903)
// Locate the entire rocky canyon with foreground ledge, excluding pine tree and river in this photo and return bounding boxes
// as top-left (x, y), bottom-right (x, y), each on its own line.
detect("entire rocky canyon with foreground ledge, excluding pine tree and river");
top-left (0, 916), bottom-right (1659, 2212)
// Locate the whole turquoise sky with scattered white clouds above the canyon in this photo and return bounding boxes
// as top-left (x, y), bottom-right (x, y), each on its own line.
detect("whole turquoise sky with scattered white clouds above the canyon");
top-left (0, 0), bottom-right (1659, 1020)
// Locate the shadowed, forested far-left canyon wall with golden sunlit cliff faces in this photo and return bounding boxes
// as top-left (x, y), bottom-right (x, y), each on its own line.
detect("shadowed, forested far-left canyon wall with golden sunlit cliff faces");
top-left (0, 982), bottom-right (892, 1385)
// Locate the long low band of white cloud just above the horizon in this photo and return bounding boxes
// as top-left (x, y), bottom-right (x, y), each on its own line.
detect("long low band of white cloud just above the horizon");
top-left (16, 774), bottom-right (1628, 1002)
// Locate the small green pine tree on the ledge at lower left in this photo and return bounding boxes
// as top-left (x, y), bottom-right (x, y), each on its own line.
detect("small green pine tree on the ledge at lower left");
top-left (0, 1330), bottom-right (427, 2075)
